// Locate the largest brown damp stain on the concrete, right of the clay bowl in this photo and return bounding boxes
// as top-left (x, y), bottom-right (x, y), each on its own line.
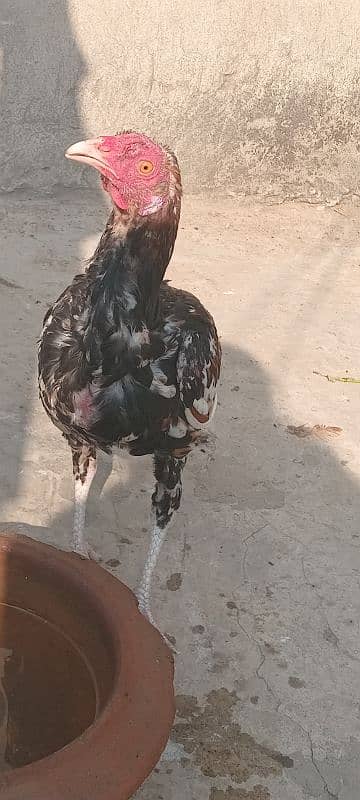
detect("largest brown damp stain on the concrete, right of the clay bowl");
top-left (173, 688), bottom-right (294, 780)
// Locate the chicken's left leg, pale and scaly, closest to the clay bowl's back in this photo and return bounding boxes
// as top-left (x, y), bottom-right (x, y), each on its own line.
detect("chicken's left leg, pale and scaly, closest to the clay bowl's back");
top-left (71, 445), bottom-right (96, 558)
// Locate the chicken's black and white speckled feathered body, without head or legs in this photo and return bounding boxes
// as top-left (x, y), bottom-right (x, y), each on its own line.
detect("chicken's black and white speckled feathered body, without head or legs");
top-left (39, 203), bottom-right (220, 455)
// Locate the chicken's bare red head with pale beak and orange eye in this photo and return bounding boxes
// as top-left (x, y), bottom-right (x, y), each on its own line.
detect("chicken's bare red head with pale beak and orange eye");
top-left (65, 132), bottom-right (170, 216)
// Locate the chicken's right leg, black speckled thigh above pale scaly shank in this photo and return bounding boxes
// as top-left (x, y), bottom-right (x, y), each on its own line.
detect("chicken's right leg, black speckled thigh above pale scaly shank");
top-left (137, 453), bottom-right (186, 625)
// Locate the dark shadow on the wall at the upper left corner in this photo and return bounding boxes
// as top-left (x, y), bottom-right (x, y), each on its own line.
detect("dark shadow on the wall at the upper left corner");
top-left (0, 0), bottom-right (86, 191)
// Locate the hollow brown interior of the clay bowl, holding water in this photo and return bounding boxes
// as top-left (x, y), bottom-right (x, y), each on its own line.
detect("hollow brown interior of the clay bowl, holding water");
top-left (0, 550), bottom-right (114, 771)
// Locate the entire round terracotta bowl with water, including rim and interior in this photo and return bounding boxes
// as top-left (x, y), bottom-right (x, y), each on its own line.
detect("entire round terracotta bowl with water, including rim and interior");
top-left (0, 535), bottom-right (174, 800)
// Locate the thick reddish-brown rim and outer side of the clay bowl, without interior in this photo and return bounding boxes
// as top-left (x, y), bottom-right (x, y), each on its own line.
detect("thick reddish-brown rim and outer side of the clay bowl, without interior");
top-left (0, 532), bottom-right (175, 800)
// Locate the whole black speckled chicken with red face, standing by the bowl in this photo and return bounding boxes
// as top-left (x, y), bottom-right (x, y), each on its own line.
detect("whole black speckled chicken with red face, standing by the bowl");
top-left (38, 132), bottom-right (221, 621)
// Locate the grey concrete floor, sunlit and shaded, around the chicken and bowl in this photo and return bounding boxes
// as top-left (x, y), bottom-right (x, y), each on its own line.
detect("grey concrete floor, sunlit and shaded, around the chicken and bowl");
top-left (0, 192), bottom-right (360, 800)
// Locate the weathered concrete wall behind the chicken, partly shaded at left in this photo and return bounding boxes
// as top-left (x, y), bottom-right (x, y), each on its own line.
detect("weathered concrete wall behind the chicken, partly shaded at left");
top-left (0, 0), bottom-right (360, 200)
